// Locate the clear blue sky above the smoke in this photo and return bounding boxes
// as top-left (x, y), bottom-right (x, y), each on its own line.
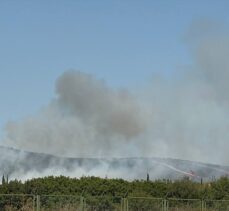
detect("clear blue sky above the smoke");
top-left (0, 0), bottom-right (229, 137)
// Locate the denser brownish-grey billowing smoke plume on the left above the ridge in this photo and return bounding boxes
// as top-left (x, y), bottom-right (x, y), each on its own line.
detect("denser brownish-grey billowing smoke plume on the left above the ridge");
top-left (3, 71), bottom-right (145, 157)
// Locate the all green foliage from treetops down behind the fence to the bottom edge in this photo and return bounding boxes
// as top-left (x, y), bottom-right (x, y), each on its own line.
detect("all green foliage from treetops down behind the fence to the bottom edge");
top-left (0, 176), bottom-right (229, 211)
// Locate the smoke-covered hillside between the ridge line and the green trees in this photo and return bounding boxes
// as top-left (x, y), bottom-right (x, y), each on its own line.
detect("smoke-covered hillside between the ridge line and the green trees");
top-left (0, 147), bottom-right (229, 182)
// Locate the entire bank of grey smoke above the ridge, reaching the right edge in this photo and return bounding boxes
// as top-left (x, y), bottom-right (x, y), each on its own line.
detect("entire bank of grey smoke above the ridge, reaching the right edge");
top-left (1, 22), bottom-right (229, 178)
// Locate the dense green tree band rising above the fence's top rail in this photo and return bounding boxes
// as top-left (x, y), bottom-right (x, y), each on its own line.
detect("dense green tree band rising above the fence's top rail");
top-left (0, 176), bottom-right (229, 200)
